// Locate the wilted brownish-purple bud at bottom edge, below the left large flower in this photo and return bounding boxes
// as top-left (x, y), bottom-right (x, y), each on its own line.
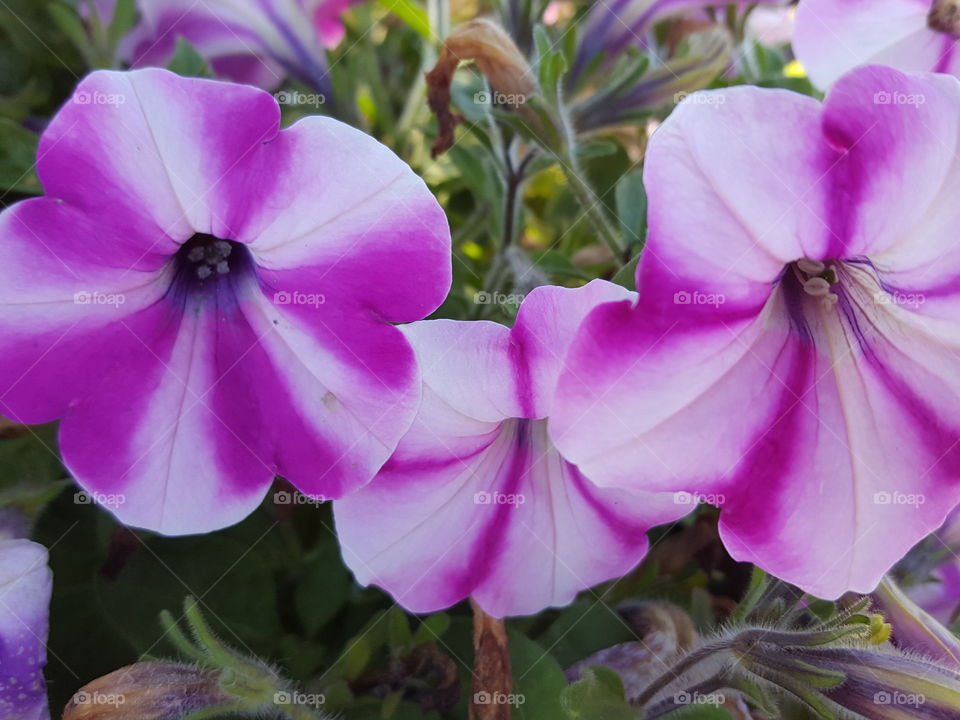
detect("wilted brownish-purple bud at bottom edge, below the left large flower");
top-left (63, 662), bottom-right (237, 720)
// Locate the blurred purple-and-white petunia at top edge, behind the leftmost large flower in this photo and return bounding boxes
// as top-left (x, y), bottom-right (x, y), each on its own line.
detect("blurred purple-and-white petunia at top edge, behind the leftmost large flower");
top-left (101, 0), bottom-right (350, 93)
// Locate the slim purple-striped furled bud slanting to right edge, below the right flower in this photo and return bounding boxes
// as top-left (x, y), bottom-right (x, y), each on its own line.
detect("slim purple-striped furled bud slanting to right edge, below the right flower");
top-left (873, 577), bottom-right (960, 670)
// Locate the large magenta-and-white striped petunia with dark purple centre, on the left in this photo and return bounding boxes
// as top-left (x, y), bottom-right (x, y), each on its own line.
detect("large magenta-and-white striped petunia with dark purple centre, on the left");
top-left (0, 69), bottom-right (451, 534)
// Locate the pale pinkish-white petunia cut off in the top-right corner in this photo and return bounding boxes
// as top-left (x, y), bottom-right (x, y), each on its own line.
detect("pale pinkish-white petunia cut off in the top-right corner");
top-left (794, 0), bottom-right (960, 88)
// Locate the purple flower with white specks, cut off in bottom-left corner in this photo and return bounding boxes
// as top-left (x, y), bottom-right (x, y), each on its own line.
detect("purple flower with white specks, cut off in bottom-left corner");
top-left (0, 540), bottom-right (53, 720)
